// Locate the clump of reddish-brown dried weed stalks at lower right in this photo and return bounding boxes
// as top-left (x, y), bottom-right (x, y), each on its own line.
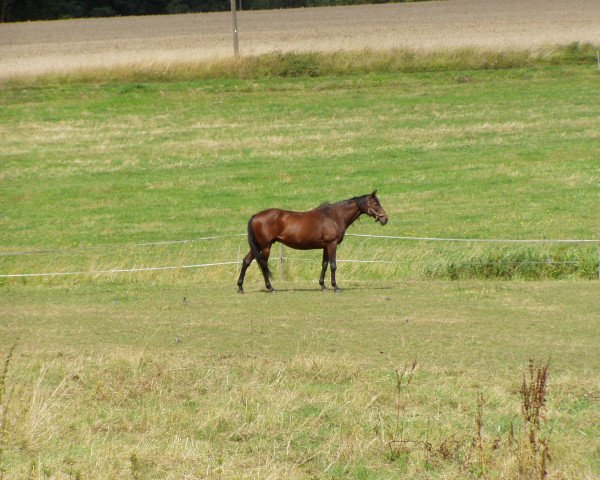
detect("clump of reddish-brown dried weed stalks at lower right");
top-left (382, 359), bottom-right (551, 480)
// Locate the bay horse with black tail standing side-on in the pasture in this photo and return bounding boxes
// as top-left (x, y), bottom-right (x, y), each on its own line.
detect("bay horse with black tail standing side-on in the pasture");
top-left (237, 190), bottom-right (388, 293)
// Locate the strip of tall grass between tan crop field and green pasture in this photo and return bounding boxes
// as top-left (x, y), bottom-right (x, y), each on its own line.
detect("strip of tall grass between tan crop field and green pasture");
top-left (6, 42), bottom-right (597, 84)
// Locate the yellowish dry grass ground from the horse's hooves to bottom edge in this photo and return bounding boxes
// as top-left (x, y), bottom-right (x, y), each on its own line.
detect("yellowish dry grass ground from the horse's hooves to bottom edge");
top-left (0, 282), bottom-right (599, 479)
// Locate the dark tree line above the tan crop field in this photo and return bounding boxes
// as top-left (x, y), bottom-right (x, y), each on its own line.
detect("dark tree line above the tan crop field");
top-left (0, 0), bottom-right (402, 22)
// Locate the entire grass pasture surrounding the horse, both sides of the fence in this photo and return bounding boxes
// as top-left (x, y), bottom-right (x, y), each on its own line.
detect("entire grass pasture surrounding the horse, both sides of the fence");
top-left (0, 57), bottom-right (600, 479)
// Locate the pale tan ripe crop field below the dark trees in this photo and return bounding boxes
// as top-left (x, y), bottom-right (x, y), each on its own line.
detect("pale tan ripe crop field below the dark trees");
top-left (0, 0), bottom-right (600, 78)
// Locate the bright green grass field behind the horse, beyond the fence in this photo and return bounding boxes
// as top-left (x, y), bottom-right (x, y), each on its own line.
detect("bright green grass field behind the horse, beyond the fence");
top-left (0, 62), bottom-right (600, 279)
